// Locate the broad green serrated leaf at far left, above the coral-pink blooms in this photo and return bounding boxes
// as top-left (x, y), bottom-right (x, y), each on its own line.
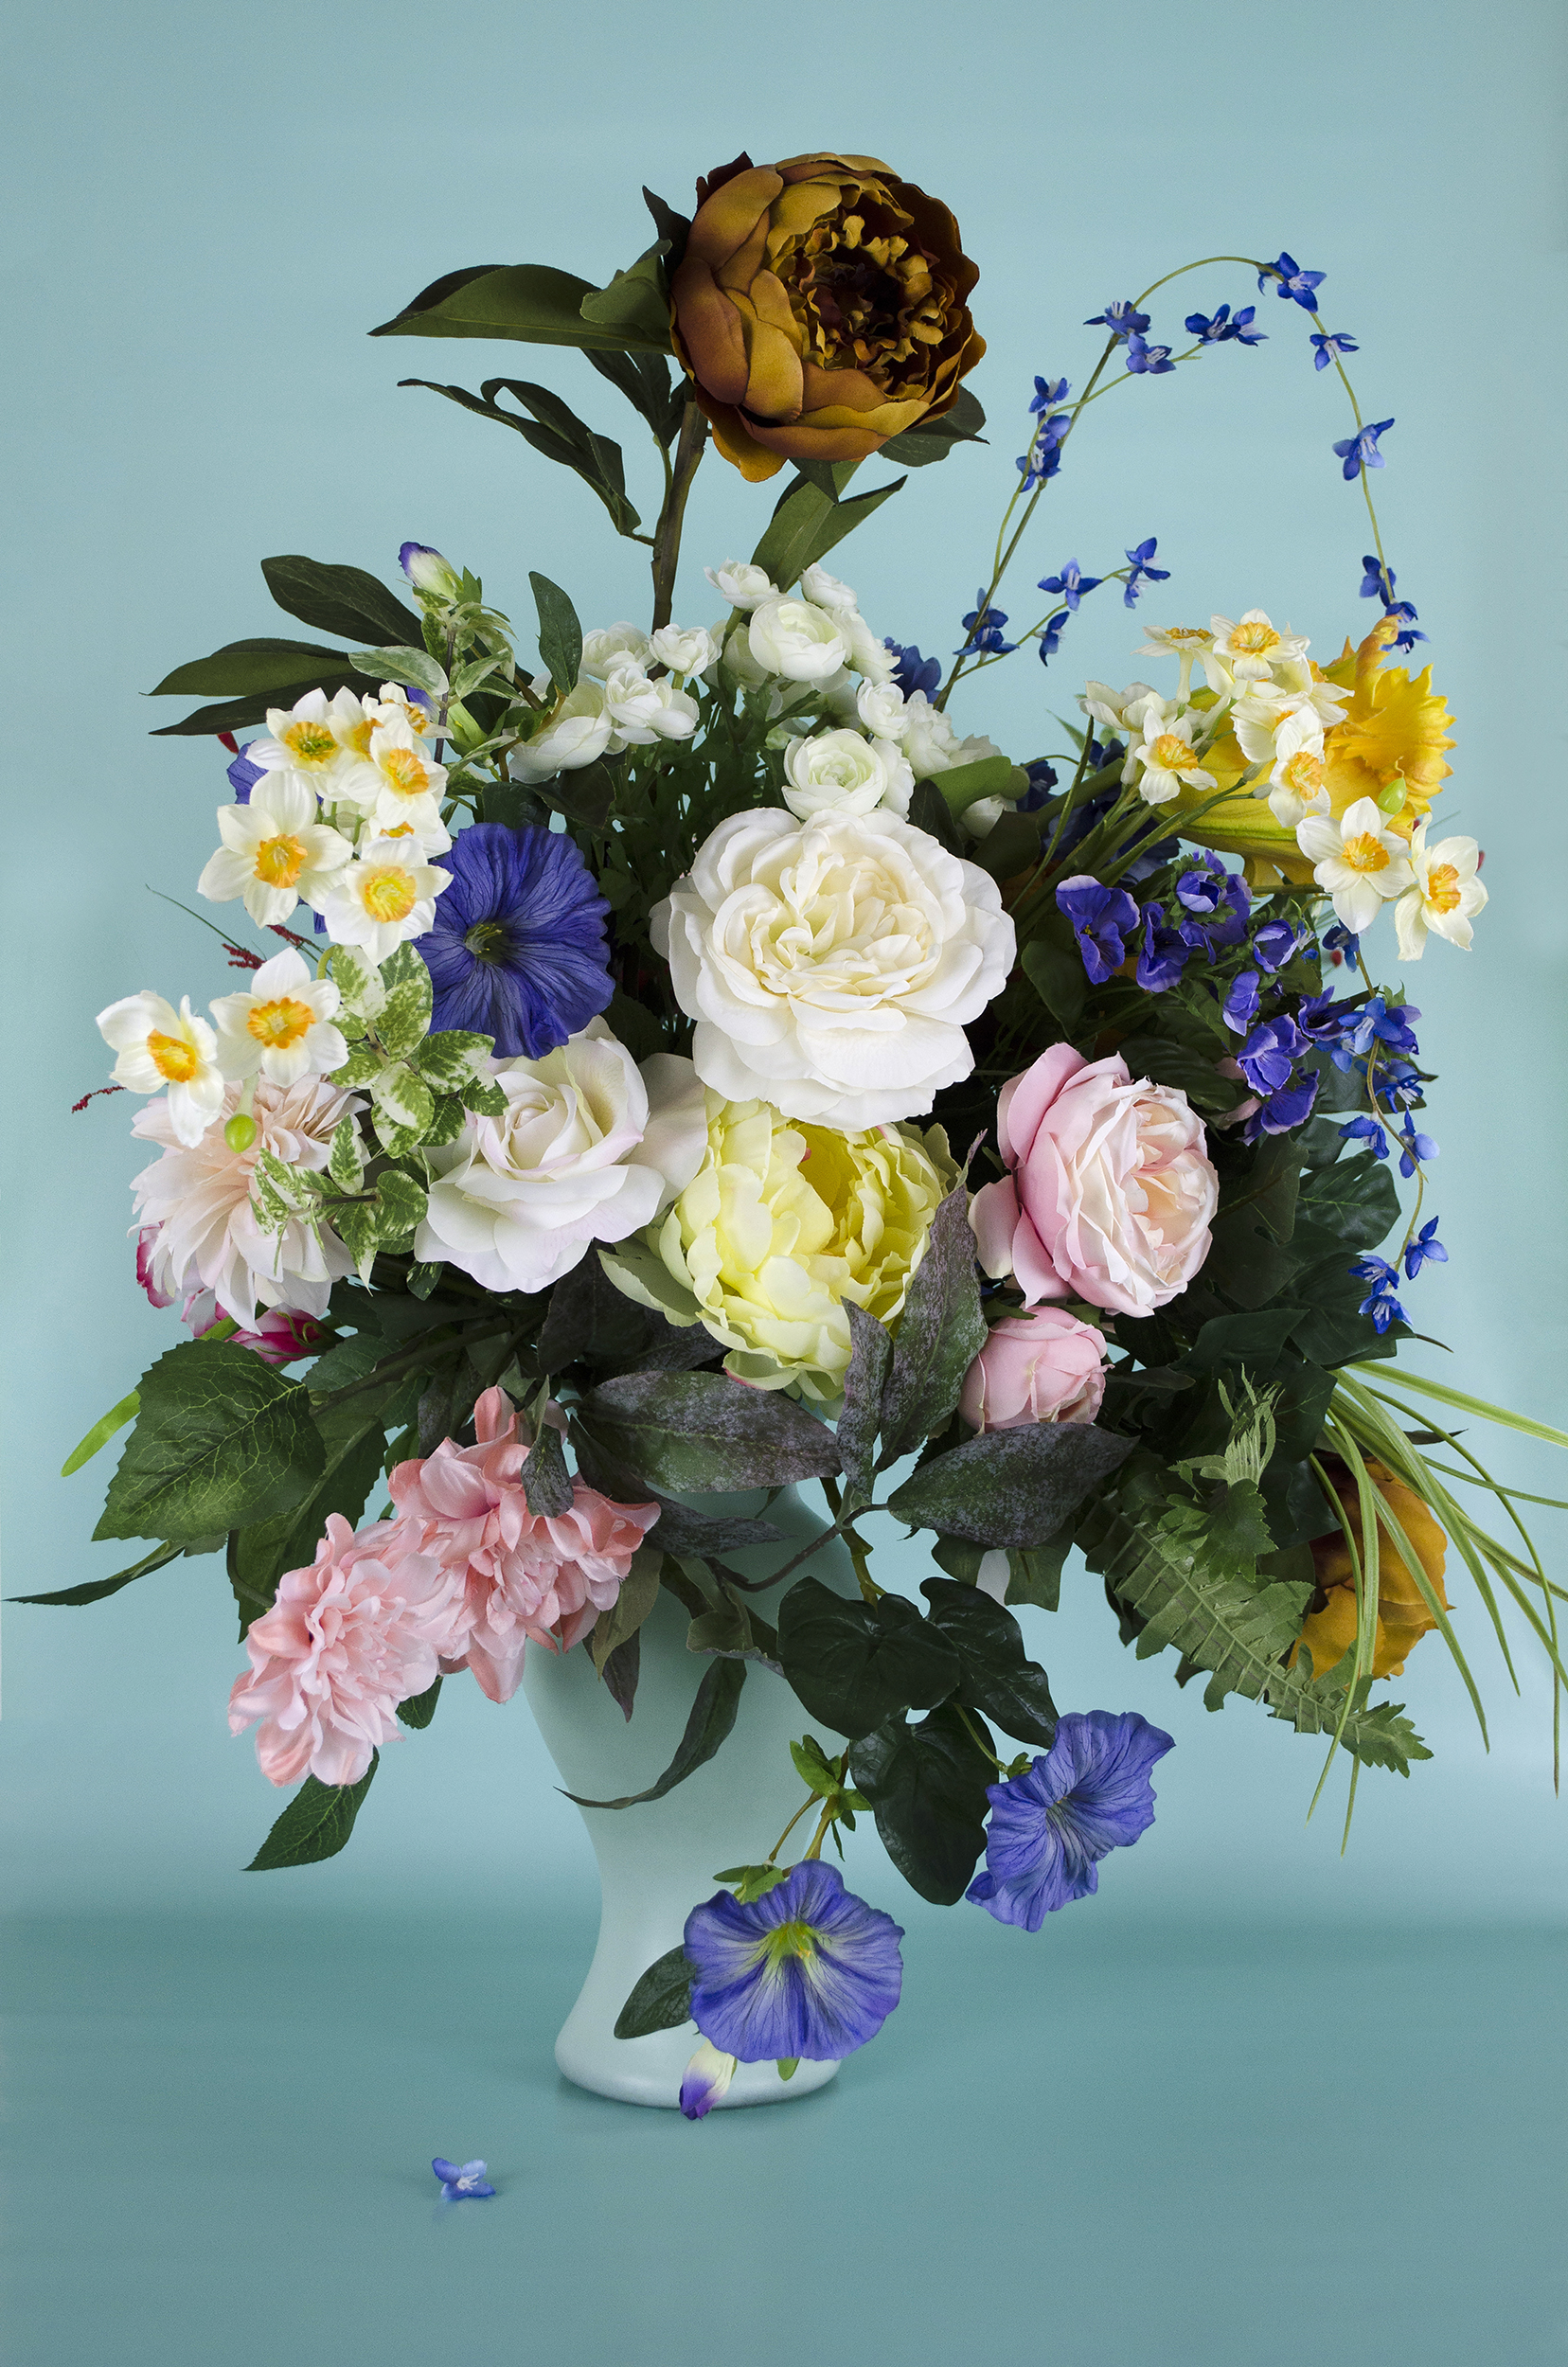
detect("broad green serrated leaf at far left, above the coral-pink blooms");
top-left (93, 1340), bottom-right (325, 1546)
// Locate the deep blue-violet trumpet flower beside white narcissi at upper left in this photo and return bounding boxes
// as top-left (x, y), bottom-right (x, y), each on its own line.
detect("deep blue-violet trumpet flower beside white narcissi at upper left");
top-left (415, 822), bottom-right (614, 1060)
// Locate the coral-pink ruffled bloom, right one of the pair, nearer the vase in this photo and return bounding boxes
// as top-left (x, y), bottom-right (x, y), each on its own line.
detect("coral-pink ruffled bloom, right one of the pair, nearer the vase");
top-left (391, 1390), bottom-right (658, 1702)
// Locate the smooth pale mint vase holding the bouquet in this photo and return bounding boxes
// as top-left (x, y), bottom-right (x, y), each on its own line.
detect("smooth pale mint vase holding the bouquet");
top-left (524, 1489), bottom-right (855, 2107)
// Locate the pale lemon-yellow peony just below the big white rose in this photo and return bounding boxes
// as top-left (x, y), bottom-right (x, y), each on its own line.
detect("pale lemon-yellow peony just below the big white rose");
top-left (599, 1092), bottom-right (957, 1401)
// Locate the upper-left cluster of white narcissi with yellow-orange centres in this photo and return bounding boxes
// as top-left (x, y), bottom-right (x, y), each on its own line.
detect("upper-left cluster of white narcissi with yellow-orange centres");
top-left (197, 682), bottom-right (453, 961)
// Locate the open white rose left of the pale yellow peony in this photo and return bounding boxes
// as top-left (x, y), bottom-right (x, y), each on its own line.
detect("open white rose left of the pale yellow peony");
top-left (415, 1021), bottom-right (708, 1290)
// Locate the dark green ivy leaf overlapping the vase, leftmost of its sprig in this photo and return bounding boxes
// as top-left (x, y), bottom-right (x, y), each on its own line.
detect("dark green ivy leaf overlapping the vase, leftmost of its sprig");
top-left (779, 1579), bottom-right (959, 1737)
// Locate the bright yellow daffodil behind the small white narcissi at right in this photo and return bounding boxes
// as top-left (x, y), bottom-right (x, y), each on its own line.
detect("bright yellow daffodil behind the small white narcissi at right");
top-left (1170, 618), bottom-right (1454, 888)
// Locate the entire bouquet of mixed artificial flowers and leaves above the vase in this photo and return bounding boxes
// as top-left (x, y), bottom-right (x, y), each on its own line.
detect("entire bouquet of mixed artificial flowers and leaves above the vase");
top-left (52, 154), bottom-right (1568, 2119)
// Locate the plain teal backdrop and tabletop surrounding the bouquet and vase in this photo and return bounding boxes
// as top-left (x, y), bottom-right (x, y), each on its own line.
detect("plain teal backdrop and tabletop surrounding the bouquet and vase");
top-left (0, 0), bottom-right (1568, 2367)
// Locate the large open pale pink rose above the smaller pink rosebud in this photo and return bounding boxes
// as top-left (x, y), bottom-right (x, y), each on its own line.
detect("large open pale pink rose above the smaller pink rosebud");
top-left (969, 1044), bottom-right (1220, 1316)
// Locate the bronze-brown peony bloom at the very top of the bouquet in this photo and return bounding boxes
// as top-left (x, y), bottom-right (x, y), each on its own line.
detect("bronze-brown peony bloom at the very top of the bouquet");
top-left (670, 156), bottom-right (986, 478)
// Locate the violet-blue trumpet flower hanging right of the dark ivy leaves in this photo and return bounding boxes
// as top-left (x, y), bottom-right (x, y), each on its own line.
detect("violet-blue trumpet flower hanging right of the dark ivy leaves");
top-left (964, 1709), bottom-right (1175, 1931)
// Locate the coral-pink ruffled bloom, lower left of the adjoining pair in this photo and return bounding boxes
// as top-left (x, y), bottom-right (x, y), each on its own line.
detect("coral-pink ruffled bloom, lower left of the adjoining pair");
top-left (230, 1513), bottom-right (454, 1785)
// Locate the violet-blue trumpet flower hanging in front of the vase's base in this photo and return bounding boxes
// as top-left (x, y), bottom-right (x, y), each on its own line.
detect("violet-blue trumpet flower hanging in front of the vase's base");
top-left (685, 1859), bottom-right (905, 2064)
